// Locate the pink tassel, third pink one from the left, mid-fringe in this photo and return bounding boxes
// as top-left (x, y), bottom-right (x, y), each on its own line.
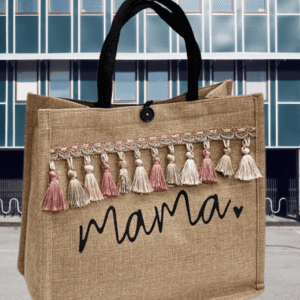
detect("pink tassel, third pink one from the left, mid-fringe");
top-left (150, 148), bottom-right (168, 191)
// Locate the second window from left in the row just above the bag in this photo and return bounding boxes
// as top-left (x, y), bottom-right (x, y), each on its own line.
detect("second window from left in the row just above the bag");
top-left (49, 60), bottom-right (71, 98)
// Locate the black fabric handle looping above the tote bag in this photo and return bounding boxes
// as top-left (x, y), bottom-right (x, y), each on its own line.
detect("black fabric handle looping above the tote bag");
top-left (93, 0), bottom-right (202, 108)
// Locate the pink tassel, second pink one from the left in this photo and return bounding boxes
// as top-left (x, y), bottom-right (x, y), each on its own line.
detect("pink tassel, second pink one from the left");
top-left (101, 153), bottom-right (120, 198)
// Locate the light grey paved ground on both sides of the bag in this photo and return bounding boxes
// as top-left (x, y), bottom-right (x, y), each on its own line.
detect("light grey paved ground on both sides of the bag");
top-left (0, 227), bottom-right (300, 300)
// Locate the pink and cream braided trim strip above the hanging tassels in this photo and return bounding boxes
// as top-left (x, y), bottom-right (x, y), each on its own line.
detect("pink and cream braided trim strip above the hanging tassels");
top-left (50, 126), bottom-right (256, 160)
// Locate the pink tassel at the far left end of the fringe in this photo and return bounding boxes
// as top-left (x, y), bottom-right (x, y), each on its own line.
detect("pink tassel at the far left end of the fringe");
top-left (43, 161), bottom-right (68, 211)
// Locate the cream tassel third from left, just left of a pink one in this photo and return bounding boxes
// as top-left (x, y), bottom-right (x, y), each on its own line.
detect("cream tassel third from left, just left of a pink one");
top-left (84, 155), bottom-right (104, 201)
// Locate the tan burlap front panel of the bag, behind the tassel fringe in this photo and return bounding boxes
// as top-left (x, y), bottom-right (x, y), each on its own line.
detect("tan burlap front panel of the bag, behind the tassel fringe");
top-left (33, 95), bottom-right (264, 300)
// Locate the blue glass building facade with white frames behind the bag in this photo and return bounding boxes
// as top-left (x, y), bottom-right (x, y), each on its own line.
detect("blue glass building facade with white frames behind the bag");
top-left (0, 0), bottom-right (300, 216)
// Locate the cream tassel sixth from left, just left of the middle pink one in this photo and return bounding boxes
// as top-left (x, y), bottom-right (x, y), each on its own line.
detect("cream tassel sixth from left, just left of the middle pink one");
top-left (132, 149), bottom-right (153, 194)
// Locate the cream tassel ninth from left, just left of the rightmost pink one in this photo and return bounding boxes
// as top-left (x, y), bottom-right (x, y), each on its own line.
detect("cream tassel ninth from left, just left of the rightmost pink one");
top-left (180, 143), bottom-right (202, 185)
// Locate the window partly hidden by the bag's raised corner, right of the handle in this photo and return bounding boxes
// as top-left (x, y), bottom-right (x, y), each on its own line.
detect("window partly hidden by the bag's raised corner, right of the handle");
top-left (212, 60), bottom-right (235, 95)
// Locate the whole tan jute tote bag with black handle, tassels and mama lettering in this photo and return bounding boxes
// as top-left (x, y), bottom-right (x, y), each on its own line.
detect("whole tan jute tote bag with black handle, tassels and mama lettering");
top-left (18, 0), bottom-right (265, 300)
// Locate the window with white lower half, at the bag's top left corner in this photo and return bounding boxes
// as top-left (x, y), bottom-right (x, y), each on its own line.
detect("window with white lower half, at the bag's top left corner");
top-left (16, 60), bottom-right (38, 102)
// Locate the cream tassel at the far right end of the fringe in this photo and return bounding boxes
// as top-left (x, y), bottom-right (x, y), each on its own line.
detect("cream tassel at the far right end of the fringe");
top-left (234, 137), bottom-right (263, 181)
